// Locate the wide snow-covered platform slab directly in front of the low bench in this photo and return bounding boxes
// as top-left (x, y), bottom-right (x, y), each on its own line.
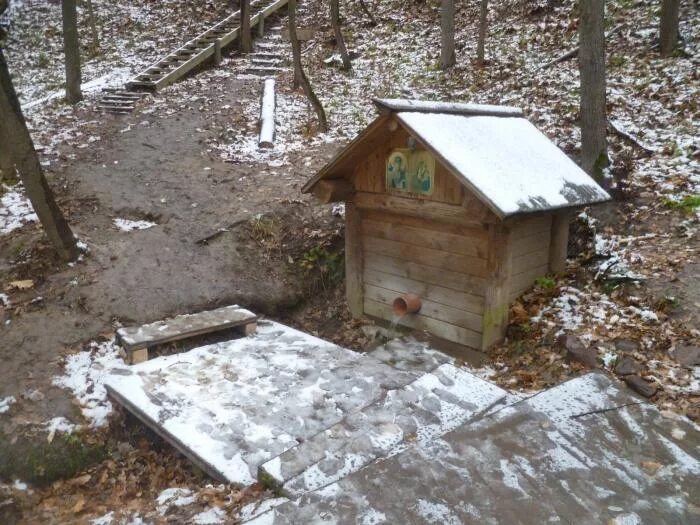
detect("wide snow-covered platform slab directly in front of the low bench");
top-left (105, 322), bottom-right (422, 485)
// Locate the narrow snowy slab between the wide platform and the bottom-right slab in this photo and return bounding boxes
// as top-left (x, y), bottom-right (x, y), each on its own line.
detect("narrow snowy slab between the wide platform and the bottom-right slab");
top-left (261, 363), bottom-right (509, 496)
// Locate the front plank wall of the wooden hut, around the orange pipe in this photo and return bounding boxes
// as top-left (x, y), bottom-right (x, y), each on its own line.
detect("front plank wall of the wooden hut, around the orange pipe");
top-left (360, 209), bottom-right (488, 348)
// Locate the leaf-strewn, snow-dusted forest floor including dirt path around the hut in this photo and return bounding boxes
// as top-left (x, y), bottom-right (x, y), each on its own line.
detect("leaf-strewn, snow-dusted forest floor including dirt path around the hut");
top-left (0, 0), bottom-right (700, 523)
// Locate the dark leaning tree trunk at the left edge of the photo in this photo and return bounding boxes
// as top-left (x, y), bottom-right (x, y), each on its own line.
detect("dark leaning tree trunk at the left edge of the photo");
top-left (0, 49), bottom-right (79, 261)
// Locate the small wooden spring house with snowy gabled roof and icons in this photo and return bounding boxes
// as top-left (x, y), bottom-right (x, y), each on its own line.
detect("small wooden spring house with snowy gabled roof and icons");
top-left (303, 99), bottom-right (609, 349)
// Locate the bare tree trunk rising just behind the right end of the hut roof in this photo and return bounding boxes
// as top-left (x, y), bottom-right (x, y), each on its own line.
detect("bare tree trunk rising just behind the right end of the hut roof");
top-left (578, 0), bottom-right (608, 181)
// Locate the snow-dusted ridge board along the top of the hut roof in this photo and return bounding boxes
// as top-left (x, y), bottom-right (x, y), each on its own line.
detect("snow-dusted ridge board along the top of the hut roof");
top-left (373, 98), bottom-right (525, 117)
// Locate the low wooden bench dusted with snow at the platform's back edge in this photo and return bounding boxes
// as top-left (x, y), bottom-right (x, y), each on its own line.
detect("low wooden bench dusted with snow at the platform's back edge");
top-left (117, 305), bottom-right (258, 364)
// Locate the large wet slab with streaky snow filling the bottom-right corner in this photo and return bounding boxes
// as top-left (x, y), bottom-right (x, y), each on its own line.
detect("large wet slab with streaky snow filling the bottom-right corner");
top-left (250, 373), bottom-right (700, 525)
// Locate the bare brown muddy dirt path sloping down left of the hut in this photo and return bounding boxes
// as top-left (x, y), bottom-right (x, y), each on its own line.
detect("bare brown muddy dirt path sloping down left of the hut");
top-left (0, 67), bottom-right (339, 486)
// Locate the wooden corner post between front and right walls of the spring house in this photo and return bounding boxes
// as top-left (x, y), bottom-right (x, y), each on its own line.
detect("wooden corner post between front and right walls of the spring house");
top-left (481, 224), bottom-right (513, 350)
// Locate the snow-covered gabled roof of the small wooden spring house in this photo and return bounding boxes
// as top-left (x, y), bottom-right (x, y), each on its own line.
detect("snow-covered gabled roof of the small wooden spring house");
top-left (303, 99), bottom-right (610, 218)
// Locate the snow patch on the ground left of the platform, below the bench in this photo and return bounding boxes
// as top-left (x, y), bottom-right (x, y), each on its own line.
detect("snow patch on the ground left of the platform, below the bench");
top-left (53, 339), bottom-right (128, 427)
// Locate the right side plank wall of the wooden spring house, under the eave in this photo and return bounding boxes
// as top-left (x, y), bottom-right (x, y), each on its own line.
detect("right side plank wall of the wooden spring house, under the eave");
top-left (510, 215), bottom-right (552, 301)
